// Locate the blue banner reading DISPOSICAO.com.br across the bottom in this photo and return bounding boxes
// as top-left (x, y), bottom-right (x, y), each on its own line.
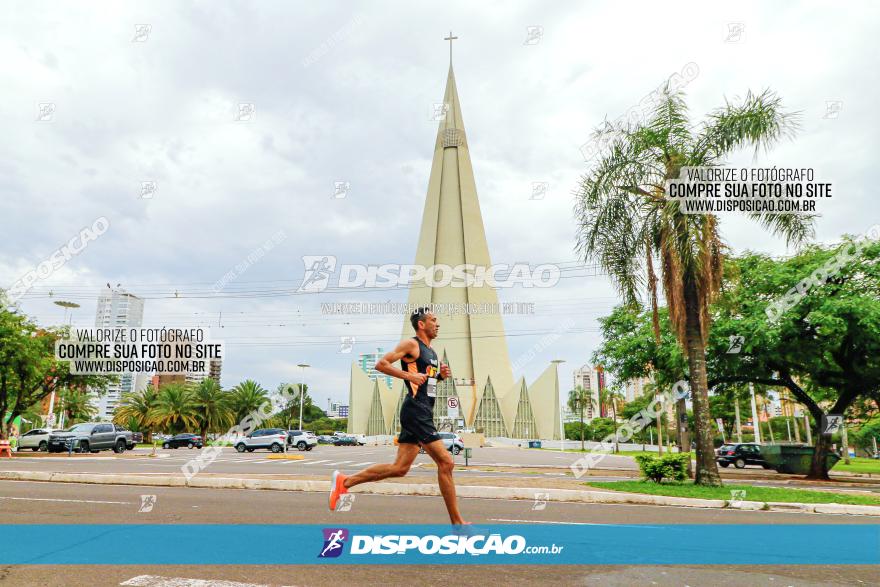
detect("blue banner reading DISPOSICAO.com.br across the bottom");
top-left (0, 524), bottom-right (880, 565)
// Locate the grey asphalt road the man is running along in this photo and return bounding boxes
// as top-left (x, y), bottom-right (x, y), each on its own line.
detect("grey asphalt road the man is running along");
top-left (0, 481), bottom-right (878, 587)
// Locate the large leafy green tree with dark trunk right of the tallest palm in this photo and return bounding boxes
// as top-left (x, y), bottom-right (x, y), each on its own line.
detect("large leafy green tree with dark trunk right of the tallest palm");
top-left (708, 237), bottom-right (880, 479)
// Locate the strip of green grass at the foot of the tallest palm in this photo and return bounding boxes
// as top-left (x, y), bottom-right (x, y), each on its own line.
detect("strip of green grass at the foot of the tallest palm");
top-left (584, 481), bottom-right (880, 505)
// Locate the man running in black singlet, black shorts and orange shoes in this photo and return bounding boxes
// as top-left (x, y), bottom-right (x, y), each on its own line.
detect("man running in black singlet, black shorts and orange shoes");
top-left (330, 308), bottom-right (467, 525)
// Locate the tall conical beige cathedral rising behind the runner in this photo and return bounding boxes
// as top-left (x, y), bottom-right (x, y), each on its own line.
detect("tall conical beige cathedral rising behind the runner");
top-left (348, 52), bottom-right (562, 439)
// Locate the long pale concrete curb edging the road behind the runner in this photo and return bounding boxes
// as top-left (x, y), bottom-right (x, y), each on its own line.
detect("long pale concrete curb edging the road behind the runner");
top-left (6, 471), bottom-right (880, 516)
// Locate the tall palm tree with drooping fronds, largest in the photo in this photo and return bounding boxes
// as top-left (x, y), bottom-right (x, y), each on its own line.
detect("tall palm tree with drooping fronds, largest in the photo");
top-left (577, 86), bottom-right (813, 485)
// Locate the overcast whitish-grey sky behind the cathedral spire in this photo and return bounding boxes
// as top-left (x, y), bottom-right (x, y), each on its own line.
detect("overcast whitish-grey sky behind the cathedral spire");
top-left (0, 0), bottom-right (880, 414)
